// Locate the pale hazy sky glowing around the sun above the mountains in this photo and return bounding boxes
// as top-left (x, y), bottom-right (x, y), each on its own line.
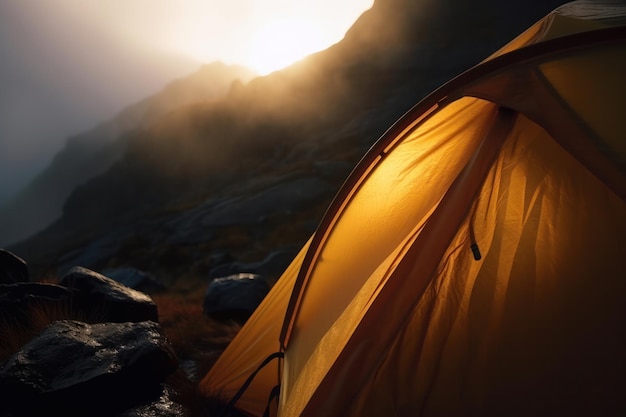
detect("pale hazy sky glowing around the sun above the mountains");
top-left (0, 0), bottom-right (373, 204)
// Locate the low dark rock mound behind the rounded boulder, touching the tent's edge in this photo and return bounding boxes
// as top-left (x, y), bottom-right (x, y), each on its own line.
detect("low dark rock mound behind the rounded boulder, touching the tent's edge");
top-left (209, 248), bottom-right (298, 279)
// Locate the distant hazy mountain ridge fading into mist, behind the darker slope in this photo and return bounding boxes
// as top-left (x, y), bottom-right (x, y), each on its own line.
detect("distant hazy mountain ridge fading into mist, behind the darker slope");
top-left (0, 62), bottom-right (254, 245)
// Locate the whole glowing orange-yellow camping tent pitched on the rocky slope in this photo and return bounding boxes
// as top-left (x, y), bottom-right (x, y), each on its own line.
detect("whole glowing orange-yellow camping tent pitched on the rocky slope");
top-left (200, 1), bottom-right (626, 417)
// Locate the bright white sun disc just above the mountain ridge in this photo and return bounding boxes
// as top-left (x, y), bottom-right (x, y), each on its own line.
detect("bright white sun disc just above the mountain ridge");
top-left (249, 19), bottom-right (330, 75)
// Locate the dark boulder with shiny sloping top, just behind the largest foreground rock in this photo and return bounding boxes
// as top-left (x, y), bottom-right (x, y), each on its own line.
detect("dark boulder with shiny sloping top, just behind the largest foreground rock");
top-left (60, 266), bottom-right (159, 323)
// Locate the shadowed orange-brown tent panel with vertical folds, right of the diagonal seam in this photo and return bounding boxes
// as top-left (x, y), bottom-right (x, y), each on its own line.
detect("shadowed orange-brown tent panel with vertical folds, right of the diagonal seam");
top-left (290, 112), bottom-right (626, 416)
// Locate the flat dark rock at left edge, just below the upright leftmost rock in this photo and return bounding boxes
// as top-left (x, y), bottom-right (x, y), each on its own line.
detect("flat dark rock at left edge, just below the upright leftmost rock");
top-left (0, 282), bottom-right (73, 324)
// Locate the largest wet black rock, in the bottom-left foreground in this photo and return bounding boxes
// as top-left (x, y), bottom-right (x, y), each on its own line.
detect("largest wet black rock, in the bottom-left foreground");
top-left (0, 321), bottom-right (177, 416)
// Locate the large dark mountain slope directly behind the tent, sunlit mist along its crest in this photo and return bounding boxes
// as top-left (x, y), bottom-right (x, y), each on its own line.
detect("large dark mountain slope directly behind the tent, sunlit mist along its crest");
top-left (10, 0), bottom-right (563, 281)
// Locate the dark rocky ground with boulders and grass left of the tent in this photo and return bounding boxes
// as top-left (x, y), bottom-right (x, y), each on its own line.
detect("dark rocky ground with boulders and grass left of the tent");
top-left (0, 250), bottom-right (269, 417)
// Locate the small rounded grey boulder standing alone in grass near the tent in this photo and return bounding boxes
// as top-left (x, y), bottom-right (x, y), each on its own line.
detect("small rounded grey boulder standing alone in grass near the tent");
top-left (204, 273), bottom-right (270, 321)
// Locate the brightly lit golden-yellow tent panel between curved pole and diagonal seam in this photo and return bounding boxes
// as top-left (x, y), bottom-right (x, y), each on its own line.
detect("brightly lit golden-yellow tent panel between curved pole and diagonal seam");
top-left (281, 98), bottom-right (504, 415)
